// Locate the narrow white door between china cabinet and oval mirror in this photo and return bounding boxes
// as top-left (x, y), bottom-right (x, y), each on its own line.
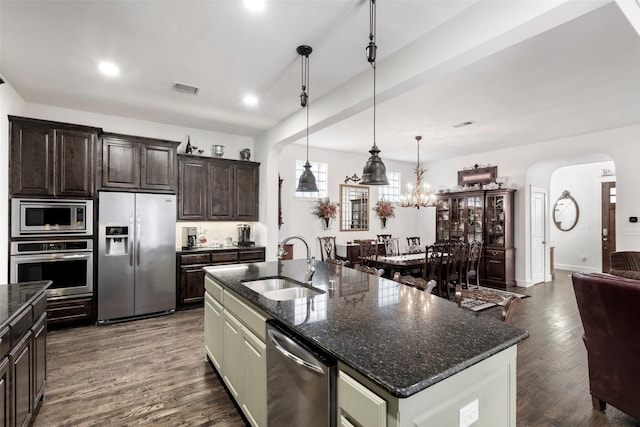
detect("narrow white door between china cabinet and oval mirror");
top-left (531, 187), bottom-right (547, 285)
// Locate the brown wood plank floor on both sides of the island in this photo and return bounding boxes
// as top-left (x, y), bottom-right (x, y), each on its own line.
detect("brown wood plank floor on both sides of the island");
top-left (35, 271), bottom-right (640, 427)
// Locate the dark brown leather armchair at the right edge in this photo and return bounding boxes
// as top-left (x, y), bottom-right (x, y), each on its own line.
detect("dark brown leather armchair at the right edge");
top-left (572, 273), bottom-right (640, 419)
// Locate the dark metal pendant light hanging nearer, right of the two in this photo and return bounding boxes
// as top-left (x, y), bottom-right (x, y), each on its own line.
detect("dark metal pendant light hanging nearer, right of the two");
top-left (360, 0), bottom-right (389, 185)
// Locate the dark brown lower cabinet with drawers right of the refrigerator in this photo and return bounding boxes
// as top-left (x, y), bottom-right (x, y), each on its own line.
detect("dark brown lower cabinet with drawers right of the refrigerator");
top-left (176, 247), bottom-right (265, 310)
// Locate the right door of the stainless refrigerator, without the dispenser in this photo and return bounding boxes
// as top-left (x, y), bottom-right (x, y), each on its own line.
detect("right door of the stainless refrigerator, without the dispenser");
top-left (134, 193), bottom-right (176, 316)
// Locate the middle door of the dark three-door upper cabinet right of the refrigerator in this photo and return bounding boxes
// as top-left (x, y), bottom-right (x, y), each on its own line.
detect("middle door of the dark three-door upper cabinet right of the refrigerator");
top-left (207, 162), bottom-right (234, 220)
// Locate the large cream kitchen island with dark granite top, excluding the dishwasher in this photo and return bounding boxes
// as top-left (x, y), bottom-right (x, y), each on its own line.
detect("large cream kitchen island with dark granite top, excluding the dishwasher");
top-left (205, 260), bottom-right (528, 426)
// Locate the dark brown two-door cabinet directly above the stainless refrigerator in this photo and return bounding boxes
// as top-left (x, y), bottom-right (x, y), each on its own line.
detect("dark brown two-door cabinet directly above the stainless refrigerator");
top-left (99, 133), bottom-right (180, 193)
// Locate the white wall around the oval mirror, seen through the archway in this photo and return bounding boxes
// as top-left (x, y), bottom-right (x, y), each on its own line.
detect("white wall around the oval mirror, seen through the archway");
top-left (549, 162), bottom-right (615, 272)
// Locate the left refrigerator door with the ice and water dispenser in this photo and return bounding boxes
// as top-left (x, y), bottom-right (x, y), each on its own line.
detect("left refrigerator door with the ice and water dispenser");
top-left (98, 192), bottom-right (135, 321)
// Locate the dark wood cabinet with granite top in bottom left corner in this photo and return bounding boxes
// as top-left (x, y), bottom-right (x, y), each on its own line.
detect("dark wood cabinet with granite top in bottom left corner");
top-left (0, 280), bottom-right (51, 425)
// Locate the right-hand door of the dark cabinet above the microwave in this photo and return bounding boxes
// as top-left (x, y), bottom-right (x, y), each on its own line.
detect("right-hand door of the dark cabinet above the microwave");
top-left (55, 130), bottom-right (96, 197)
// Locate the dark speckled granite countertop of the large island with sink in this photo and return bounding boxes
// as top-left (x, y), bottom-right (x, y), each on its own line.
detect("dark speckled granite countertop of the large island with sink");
top-left (205, 260), bottom-right (529, 398)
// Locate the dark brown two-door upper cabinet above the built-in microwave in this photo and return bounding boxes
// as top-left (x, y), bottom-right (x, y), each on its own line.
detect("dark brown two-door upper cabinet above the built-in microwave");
top-left (9, 116), bottom-right (101, 198)
